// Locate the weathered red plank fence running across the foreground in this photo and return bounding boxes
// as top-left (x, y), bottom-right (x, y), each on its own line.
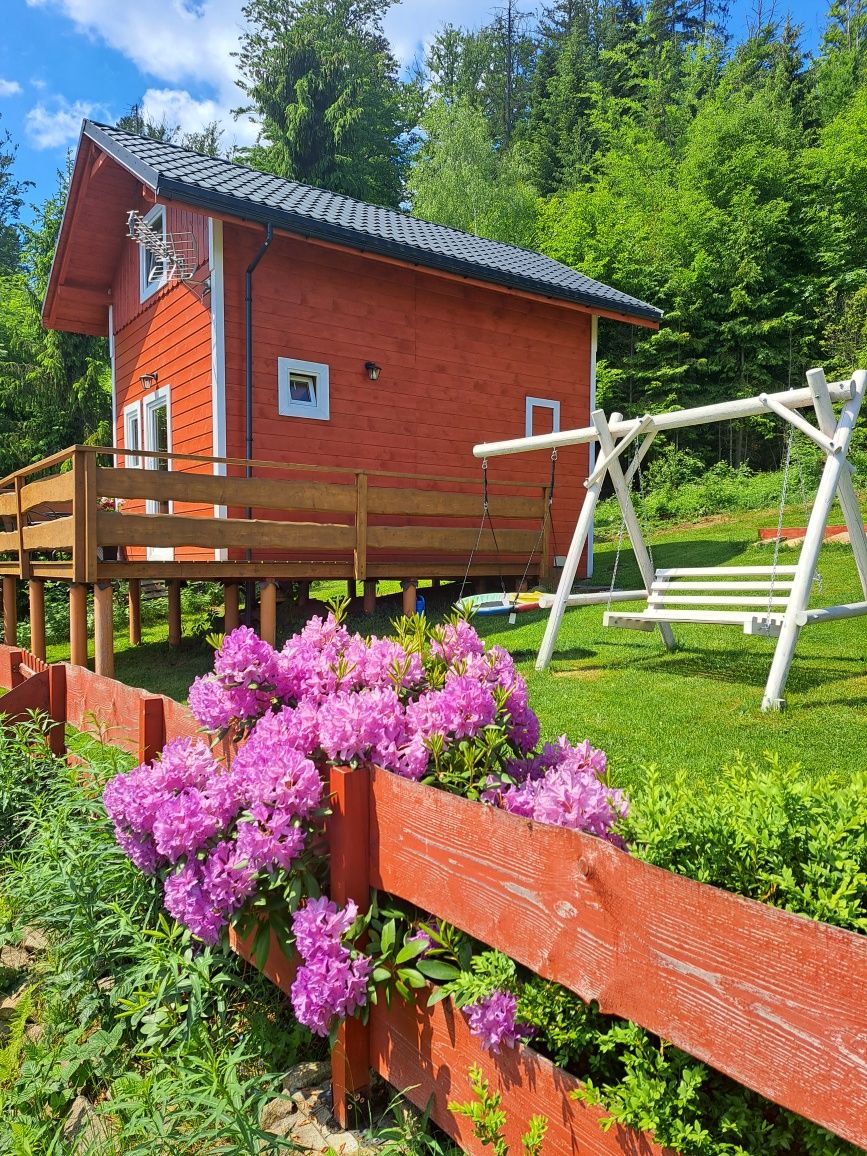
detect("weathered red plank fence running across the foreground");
top-left (0, 647), bottom-right (867, 1156)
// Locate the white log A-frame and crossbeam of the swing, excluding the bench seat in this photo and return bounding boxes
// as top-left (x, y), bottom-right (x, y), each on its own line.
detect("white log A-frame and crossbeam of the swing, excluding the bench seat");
top-left (473, 369), bottom-right (867, 710)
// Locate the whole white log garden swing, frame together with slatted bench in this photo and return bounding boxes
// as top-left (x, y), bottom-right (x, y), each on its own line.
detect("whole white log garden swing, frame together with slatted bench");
top-left (473, 369), bottom-right (867, 710)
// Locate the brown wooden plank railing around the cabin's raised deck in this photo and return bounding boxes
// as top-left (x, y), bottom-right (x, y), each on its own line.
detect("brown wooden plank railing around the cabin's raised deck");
top-left (0, 446), bottom-right (550, 583)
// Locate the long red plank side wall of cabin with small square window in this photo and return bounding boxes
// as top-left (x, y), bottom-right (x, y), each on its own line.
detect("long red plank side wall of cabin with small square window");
top-left (223, 221), bottom-right (591, 571)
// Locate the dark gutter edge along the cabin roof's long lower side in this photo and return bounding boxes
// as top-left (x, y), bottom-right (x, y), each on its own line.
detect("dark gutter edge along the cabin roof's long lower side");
top-left (156, 176), bottom-right (662, 323)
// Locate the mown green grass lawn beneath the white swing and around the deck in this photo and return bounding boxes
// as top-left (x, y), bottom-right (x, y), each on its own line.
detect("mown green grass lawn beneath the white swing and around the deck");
top-left (40, 507), bottom-right (867, 785)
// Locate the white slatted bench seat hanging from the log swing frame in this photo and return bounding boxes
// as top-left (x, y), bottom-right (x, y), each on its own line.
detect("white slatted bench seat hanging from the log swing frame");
top-left (602, 566), bottom-right (796, 638)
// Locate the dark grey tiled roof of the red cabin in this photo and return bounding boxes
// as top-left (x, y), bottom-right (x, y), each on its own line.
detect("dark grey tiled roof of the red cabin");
top-left (83, 120), bottom-right (662, 321)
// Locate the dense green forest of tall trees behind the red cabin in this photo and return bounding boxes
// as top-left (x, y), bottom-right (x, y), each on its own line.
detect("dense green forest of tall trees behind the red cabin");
top-left (0, 0), bottom-right (867, 473)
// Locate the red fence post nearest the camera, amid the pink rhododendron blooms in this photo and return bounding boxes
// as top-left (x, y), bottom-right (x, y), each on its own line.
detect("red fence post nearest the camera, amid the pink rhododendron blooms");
top-left (327, 766), bottom-right (370, 1128)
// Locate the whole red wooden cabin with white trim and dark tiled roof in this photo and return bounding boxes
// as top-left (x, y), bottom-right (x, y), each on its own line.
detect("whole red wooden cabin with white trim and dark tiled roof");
top-left (44, 121), bottom-right (660, 572)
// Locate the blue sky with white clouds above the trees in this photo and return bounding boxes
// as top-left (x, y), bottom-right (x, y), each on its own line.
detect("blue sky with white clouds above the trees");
top-left (0, 0), bottom-right (825, 217)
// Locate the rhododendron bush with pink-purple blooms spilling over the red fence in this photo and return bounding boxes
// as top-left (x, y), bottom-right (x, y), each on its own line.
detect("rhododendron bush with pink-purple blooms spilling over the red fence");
top-left (104, 614), bottom-right (627, 1050)
